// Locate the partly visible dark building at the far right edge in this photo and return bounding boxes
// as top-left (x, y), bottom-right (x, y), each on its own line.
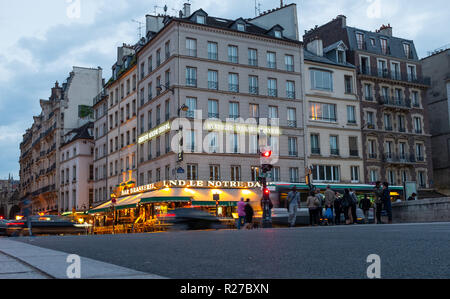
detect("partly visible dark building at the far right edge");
top-left (422, 47), bottom-right (450, 195)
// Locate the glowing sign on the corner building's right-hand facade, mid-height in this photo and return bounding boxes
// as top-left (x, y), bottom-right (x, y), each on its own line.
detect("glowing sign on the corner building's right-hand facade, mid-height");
top-left (204, 121), bottom-right (281, 135)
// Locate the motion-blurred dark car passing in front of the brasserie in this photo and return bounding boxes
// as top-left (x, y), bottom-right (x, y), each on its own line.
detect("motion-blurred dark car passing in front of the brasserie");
top-left (158, 208), bottom-right (225, 230)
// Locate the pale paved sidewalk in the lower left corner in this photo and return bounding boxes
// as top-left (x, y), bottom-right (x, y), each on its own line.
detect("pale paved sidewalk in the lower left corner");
top-left (0, 238), bottom-right (165, 279)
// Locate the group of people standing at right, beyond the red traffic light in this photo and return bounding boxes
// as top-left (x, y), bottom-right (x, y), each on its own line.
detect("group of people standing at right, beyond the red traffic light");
top-left (288, 182), bottom-right (392, 227)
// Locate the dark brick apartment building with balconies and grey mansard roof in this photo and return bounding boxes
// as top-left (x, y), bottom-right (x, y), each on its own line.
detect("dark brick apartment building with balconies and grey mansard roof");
top-left (304, 15), bottom-right (433, 189)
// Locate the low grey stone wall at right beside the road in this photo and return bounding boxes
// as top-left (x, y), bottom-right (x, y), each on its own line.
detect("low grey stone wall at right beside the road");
top-left (392, 197), bottom-right (450, 223)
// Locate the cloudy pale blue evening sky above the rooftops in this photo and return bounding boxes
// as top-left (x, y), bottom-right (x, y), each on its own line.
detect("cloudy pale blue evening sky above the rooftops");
top-left (0, 0), bottom-right (450, 179)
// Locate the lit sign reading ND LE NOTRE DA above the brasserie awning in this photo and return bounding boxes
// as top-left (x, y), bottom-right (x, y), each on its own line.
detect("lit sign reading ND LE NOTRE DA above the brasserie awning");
top-left (122, 180), bottom-right (261, 196)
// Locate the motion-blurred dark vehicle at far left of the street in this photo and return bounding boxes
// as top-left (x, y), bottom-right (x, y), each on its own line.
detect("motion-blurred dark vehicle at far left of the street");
top-left (0, 215), bottom-right (87, 237)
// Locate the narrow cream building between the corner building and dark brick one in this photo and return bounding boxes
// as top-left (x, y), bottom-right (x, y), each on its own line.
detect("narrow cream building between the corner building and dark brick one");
top-left (303, 38), bottom-right (365, 183)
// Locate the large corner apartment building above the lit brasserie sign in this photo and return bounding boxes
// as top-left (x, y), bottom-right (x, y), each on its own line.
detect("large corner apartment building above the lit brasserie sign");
top-left (136, 4), bottom-right (305, 185)
